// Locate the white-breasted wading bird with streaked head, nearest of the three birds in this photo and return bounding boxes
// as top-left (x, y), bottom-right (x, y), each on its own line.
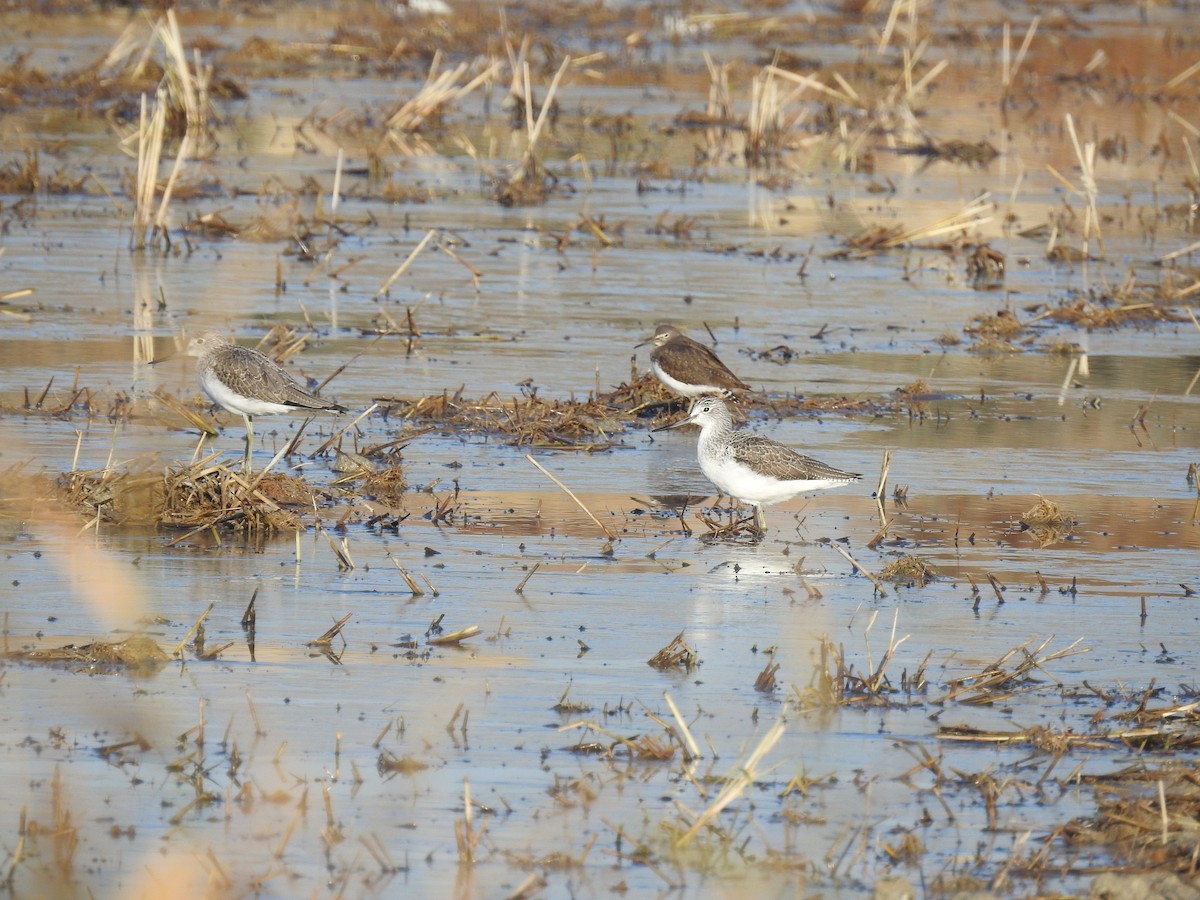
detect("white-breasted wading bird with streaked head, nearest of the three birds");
top-left (654, 397), bottom-right (859, 535)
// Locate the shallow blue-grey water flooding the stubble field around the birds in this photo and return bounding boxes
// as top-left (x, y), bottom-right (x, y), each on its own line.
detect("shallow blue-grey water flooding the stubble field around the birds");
top-left (0, 7), bottom-right (1200, 896)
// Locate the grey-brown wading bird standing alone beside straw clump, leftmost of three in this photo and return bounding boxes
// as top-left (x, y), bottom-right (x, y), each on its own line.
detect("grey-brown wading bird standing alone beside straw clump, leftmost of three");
top-left (185, 331), bottom-right (346, 473)
